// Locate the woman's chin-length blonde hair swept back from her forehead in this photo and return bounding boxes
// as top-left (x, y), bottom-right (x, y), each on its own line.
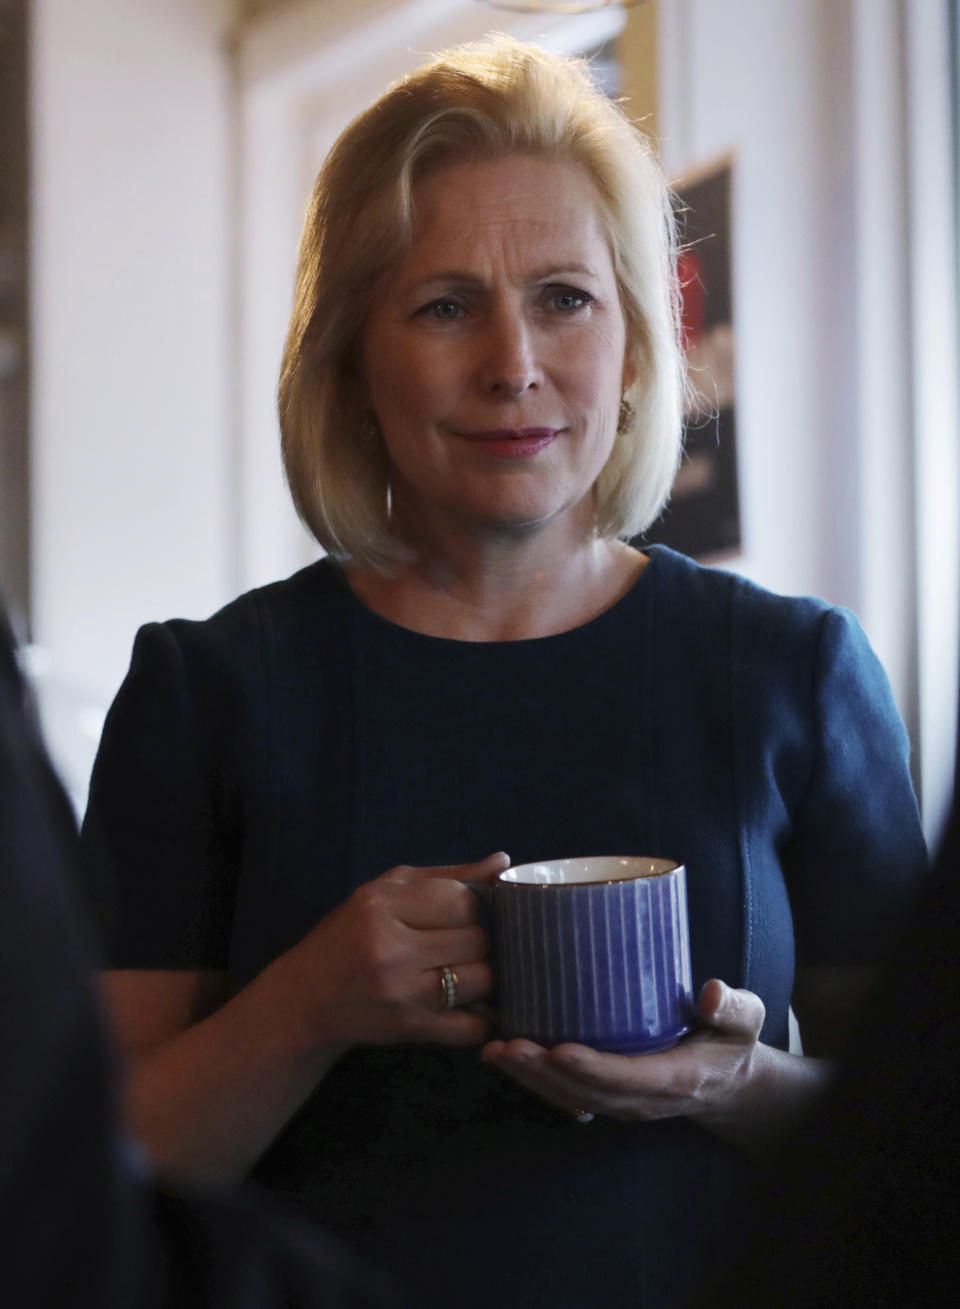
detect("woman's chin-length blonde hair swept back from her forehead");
top-left (279, 37), bottom-right (684, 571)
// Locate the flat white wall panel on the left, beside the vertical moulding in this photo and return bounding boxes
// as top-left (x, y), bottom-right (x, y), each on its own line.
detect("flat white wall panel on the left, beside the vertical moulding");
top-left (31, 0), bottom-right (232, 722)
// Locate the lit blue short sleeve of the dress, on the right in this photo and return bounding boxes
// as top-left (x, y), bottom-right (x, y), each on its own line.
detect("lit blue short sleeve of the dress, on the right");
top-left (785, 609), bottom-right (927, 965)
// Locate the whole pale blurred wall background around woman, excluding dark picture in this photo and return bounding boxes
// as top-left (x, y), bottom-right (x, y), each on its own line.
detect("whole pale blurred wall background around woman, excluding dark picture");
top-left (0, 0), bottom-right (960, 838)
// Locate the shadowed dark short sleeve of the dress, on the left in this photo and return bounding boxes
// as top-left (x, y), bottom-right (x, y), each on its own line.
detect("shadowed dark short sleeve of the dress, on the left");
top-left (81, 623), bottom-right (236, 969)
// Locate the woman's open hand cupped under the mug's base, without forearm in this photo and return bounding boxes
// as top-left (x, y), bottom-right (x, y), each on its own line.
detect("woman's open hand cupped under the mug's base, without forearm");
top-left (483, 978), bottom-right (770, 1136)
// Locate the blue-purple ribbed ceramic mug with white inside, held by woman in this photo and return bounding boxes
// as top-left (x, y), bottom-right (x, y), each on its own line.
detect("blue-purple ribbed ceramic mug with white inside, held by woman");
top-left (474, 855), bottom-right (694, 1054)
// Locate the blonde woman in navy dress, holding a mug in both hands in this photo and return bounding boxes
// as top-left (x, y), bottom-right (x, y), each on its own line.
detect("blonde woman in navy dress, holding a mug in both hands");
top-left (85, 39), bottom-right (923, 1306)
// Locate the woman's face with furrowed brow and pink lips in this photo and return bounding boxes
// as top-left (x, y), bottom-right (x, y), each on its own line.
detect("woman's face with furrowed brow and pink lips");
top-left (363, 156), bottom-right (631, 543)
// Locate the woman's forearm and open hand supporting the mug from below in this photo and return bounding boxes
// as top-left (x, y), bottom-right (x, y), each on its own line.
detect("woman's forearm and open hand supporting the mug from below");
top-left (483, 969), bottom-right (866, 1151)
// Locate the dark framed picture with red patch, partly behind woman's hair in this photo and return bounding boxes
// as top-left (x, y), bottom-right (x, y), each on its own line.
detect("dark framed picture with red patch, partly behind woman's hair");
top-left (644, 156), bottom-right (740, 559)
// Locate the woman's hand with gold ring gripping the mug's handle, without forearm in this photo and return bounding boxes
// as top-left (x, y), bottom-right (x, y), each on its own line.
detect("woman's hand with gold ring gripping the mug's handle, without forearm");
top-left (271, 852), bottom-right (509, 1049)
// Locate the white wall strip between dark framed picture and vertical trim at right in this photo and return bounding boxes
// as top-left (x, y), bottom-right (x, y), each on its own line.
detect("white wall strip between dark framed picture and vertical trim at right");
top-left (660, 0), bottom-right (850, 600)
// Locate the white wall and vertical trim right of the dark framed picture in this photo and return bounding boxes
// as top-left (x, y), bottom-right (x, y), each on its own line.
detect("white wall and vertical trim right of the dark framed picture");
top-left (659, 0), bottom-right (960, 839)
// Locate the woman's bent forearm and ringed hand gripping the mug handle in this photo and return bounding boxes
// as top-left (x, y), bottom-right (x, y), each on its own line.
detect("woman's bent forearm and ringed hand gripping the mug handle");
top-left (106, 855), bottom-right (508, 1179)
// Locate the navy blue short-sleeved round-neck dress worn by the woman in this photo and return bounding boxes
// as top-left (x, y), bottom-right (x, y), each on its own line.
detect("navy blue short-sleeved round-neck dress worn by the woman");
top-left (84, 547), bottom-right (925, 1309)
